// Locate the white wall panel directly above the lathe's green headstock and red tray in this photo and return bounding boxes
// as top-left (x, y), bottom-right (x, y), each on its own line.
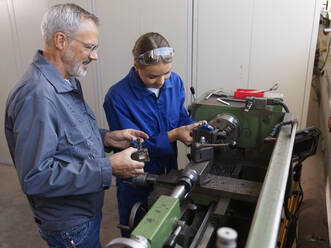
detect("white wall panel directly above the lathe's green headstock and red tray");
top-left (195, 0), bottom-right (254, 96)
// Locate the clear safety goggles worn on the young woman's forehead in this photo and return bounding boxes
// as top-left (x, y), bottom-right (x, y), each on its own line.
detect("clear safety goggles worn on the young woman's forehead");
top-left (136, 47), bottom-right (175, 65)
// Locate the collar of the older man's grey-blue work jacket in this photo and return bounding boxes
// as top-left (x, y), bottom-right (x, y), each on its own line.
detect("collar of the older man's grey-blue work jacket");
top-left (32, 50), bottom-right (77, 93)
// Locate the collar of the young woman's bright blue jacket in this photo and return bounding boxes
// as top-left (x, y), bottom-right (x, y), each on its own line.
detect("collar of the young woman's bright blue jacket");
top-left (128, 67), bottom-right (174, 100)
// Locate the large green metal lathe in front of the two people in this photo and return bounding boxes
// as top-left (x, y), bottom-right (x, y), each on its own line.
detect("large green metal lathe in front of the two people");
top-left (106, 91), bottom-right (320, 248)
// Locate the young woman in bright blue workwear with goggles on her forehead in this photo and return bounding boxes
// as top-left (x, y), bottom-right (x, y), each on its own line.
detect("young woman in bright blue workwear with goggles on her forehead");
top-left (103, 33), bottom-right (199, 237)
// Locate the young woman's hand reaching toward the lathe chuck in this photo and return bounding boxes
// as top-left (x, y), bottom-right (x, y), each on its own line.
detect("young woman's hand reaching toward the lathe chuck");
top-left (168, 121), bottom-right (206, 145)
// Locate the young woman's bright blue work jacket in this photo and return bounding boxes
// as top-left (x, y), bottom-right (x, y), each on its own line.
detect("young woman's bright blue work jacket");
top-left (103, 67), bottom-right (193, 174)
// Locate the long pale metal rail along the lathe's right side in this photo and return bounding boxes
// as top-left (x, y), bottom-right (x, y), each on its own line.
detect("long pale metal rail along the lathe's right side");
top-left (245, 113), bottom-right (297, 248)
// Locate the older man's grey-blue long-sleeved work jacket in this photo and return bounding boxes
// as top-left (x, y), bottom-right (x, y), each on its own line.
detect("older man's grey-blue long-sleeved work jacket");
top-left (5, 51), bottom-right (112, 231)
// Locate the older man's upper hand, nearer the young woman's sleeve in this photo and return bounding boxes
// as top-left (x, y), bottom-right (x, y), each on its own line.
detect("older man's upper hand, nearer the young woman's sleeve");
top-left (104, 129), bottom-right (149, 149)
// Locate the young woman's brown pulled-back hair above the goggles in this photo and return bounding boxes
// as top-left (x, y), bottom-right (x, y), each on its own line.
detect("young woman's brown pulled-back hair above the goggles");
top-left (132, 32), bottom-right (170, 67)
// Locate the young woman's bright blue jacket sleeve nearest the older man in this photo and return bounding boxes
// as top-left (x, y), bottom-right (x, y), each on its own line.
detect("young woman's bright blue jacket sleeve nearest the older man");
top-left (103, 94), bottom-right (176, 157)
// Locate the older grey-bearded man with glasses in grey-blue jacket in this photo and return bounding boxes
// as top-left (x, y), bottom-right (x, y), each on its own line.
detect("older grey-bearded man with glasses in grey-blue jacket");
top-left (5, 4), bottom-right (148, 248)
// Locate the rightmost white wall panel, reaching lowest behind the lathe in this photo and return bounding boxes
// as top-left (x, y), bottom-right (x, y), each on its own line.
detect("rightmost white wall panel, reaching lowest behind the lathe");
top-left (249, 0), bottom-right (317, 127)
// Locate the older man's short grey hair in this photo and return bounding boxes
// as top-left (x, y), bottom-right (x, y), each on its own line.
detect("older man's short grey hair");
top-left (41, 3), bottom-right (99, 45)
